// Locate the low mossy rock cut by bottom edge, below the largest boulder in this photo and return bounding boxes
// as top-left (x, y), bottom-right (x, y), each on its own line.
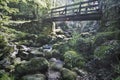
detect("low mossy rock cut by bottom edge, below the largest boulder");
top-left (22, 74), bottom-right (46, 80)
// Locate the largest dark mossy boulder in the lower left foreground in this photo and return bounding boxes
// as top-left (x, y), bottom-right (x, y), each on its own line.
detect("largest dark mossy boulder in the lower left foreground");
top-left (15, 57), bottom-right (49, 76)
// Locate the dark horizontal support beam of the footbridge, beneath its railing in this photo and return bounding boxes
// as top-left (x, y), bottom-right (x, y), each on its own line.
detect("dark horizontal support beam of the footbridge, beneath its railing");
top-left (45, 13), bottom-right (102, 22)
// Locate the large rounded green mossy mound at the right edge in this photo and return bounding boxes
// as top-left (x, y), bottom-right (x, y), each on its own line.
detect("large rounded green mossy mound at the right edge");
top-left (94, 40), bottom-right (120, 59)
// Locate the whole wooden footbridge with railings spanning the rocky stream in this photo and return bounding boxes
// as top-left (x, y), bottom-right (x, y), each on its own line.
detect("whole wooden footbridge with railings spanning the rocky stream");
top-left (45, 0), bottom-right (102, 21)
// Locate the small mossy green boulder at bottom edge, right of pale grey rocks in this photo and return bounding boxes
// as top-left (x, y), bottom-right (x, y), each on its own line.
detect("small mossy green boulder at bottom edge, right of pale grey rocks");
top-left (61, 68), bottom-right (77, 80)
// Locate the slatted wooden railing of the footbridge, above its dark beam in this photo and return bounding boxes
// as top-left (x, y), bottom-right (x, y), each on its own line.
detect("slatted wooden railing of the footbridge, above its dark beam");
top-left (46, 0), bottom-right (100, 18)
